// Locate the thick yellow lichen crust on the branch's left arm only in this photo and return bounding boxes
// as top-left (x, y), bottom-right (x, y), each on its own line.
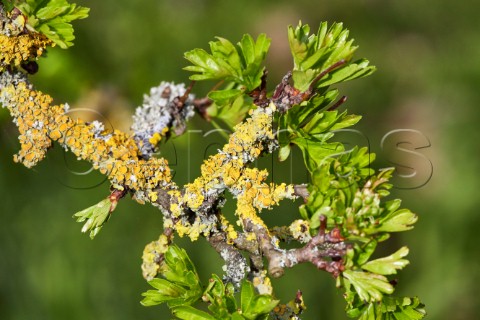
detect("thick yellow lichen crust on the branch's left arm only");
top-left (0, 75), bottom-right (171, 202)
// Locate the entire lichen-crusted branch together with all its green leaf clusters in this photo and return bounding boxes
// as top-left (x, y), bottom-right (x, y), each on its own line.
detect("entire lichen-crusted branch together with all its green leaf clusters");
top-left (0, 4), bottom-right (423, 319)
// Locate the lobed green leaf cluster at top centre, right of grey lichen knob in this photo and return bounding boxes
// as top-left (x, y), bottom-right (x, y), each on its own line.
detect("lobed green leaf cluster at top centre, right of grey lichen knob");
top-left (184, 34), bottom-right (270, 128)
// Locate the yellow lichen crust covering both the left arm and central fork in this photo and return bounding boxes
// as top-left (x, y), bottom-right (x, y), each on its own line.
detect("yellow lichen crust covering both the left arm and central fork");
top-left (0, 53), bottom-right (295, 248)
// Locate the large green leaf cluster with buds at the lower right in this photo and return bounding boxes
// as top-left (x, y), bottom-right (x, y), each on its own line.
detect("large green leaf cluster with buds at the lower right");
top-left (300, 148), bottom-right (423, 319)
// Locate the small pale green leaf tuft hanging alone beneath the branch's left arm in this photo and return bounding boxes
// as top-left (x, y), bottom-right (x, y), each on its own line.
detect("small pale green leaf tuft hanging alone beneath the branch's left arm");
top-left (73, 198), bottom-right (112, 239)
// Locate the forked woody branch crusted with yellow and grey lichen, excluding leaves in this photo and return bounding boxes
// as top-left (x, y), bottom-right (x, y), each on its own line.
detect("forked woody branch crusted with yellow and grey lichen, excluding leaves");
top-left (0, 21), bottom-right (344, 283)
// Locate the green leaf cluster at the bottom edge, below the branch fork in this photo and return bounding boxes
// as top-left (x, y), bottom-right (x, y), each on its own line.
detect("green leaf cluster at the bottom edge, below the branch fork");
top-left (141, 246), bottom-right (279, 320)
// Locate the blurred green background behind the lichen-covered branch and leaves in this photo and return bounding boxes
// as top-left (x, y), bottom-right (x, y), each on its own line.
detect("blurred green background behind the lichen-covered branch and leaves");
top-left (0, 0), bottom-right (480, 320)
